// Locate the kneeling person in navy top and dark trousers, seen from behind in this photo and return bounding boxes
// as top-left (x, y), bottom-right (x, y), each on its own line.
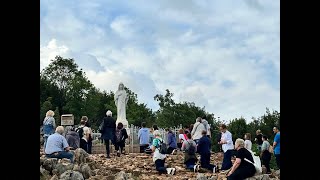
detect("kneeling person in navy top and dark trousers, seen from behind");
top-left (197, 130), bottom-right (216, 173)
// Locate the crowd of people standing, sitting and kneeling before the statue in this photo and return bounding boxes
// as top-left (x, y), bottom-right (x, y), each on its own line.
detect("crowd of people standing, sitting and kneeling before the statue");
top-left (43, 110), bottom-right (280, 180)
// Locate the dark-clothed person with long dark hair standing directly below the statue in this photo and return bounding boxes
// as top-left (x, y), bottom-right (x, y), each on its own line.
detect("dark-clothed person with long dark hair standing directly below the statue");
top-left (114, 122), bottom-right (128, 157)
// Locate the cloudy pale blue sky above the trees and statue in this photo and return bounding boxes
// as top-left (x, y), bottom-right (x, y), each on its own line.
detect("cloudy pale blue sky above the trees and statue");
top-left (40, 0), bottom-right (280, 122)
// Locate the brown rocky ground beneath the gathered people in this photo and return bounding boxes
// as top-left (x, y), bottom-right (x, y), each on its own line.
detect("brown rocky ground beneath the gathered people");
top-left (40, 148), bottom-right (280, 180)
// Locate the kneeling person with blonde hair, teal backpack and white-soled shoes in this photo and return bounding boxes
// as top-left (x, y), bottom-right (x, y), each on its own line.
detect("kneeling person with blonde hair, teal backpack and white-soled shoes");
top-left (151, 130), bottom-right (176, 174)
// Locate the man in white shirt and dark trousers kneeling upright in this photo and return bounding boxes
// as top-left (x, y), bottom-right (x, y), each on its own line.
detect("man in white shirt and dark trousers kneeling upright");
top-left (219, 124), bottom-right (234, 170)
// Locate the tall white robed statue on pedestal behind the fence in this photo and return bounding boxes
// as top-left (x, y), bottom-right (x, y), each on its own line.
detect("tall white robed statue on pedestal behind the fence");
top-left (114, 83), bottom-right (128, 128)
